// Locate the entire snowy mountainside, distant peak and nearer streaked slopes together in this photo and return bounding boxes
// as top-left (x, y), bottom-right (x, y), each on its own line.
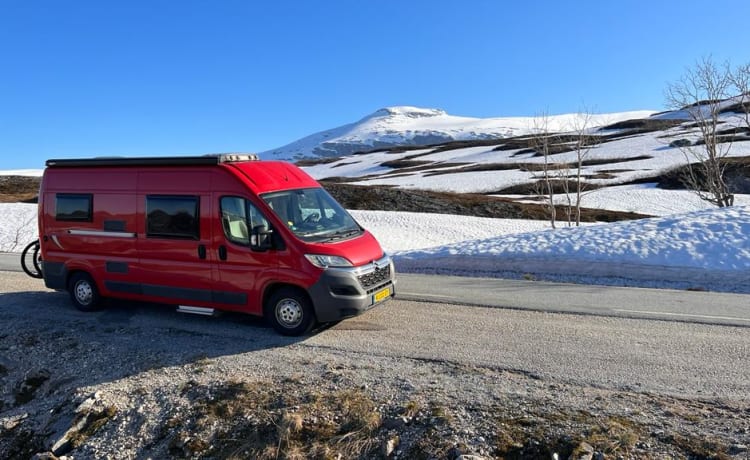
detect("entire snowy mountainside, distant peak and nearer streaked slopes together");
top-left (292, 98), bottom-right (750, 215)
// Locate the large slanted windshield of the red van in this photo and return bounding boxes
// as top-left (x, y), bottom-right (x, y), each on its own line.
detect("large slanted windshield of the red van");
top-left (261, 188), bottom-right (363, 242)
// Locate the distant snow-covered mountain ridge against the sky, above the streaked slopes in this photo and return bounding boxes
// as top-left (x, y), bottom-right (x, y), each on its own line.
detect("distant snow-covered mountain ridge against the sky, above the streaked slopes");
top-left (260, 106), bottom-right (654, 160)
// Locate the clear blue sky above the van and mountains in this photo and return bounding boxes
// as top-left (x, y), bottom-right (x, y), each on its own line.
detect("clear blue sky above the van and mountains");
top-left (0, 0), bottom-right (750, 170)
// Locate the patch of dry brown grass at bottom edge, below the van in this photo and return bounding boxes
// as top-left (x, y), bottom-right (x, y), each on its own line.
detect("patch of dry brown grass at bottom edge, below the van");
top-left (164, 380), bottom-right (381, 459)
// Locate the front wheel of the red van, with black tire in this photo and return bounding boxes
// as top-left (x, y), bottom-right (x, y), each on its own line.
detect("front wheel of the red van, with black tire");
top-left (265, 287), bottom-right (315, 336)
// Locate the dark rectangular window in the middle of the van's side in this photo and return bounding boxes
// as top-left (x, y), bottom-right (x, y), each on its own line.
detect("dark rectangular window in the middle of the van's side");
top-left (146, 195), bottom-right (200, 240)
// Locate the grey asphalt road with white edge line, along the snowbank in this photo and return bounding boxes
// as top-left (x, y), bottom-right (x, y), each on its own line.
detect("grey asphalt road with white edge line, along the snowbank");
top-left (0, 253), bottom-right (750, 327)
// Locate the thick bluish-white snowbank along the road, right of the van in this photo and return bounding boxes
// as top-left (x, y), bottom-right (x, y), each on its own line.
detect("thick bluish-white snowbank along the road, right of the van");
top-left (395, 206), bottom-right (750, 293)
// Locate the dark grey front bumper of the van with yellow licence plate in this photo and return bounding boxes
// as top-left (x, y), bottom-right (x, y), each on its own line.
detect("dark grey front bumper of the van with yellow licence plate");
top-left (308, 255), bottom-right (396, 323)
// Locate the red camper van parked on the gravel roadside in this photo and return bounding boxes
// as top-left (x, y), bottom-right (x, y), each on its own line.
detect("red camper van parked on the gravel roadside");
top-left (39, 154), bottom-right (396, 335)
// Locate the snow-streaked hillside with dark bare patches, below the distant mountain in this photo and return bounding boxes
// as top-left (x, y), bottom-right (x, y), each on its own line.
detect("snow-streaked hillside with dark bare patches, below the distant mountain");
top-left (304, 103), bottom-right (750, 215)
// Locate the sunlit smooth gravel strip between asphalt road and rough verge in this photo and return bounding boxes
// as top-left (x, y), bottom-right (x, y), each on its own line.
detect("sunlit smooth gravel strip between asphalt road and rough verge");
top-left (324, 300), bottom-right (750, 399)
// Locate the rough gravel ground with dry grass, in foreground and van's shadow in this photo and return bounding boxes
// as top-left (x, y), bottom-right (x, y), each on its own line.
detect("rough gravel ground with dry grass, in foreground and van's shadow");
top-left (0, 272), bottom-right (750, 459)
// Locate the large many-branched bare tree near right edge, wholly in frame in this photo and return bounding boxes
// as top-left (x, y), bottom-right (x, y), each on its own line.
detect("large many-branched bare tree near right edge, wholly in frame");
top-left (666, 57), bottom-right (734, 207)
